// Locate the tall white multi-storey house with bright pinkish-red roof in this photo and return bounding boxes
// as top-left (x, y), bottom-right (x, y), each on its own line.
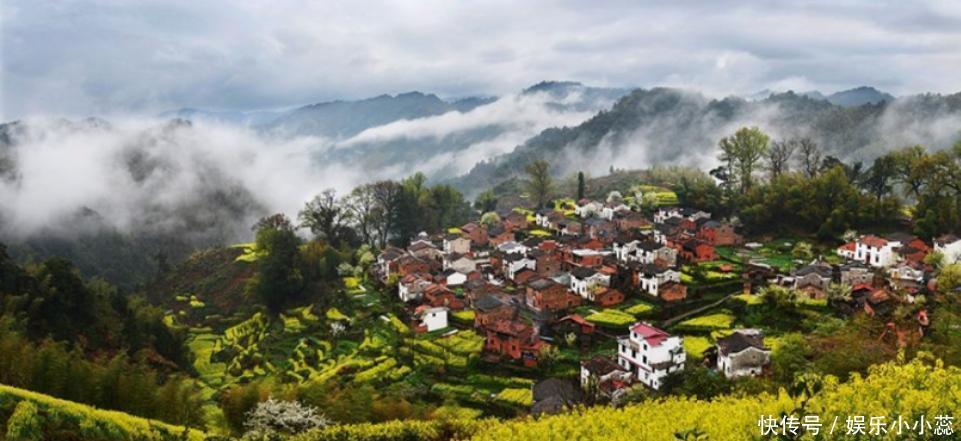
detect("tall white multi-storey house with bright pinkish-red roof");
top-left (617, 322), bottom-right (687, 389)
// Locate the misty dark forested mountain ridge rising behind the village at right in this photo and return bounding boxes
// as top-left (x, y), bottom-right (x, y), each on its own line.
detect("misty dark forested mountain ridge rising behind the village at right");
top-left (451, 88), bottom-right (961, 194)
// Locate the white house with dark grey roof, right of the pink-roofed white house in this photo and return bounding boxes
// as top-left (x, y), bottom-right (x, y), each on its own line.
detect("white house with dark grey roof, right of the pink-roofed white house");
top-left (717, 329), bottom-right (771, 378)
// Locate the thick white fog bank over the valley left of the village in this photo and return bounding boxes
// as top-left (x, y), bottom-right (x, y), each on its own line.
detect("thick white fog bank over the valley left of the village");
top-left (0, 119), bottom-right (366, 238)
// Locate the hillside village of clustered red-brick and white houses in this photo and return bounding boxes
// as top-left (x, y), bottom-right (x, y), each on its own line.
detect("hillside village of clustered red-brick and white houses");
top-left (371, 192), bottom-right (961, 414)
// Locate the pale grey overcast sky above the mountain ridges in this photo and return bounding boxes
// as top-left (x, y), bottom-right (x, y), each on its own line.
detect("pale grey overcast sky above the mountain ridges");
top-left (0, 0), bottom-right (961, 120)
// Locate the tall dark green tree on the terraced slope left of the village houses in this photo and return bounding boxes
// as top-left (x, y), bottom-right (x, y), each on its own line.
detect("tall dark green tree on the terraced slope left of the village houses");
top-left (248, 214), bottom-right (304, 313)
